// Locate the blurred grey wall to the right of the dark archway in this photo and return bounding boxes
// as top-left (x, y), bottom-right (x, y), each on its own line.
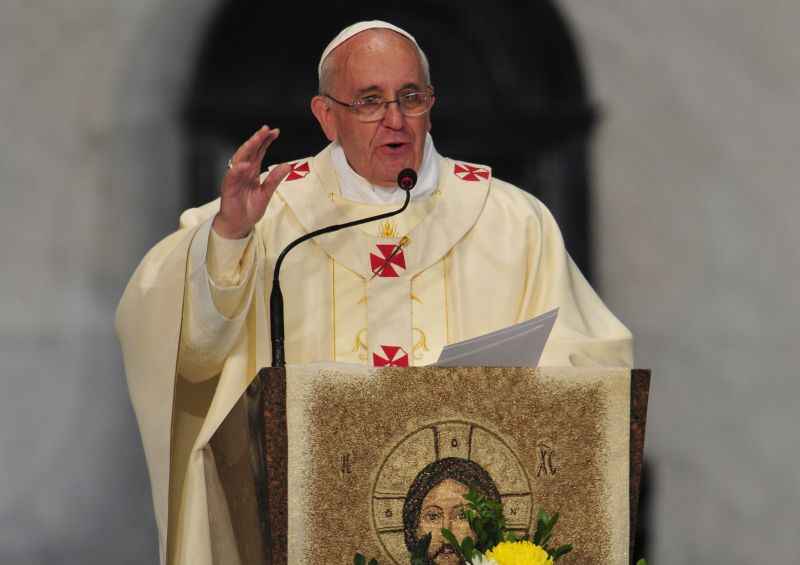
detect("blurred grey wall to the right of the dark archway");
top-left (561, 0), bottom-right (800, 563)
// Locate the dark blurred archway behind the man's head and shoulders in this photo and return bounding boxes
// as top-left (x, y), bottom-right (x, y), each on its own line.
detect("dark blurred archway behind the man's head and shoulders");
top-left (183, 0), bottom-right (597, 280)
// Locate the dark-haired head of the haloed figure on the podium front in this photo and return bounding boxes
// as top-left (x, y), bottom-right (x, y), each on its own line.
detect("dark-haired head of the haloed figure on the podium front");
top-left (403, 457), bottom-right (500, 565)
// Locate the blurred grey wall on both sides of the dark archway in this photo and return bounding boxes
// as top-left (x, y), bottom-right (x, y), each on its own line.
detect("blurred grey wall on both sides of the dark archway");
top-left (0, 0), bottom-right (800, 564)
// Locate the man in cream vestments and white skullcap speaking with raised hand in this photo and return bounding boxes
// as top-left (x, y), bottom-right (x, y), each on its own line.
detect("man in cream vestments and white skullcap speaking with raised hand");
top-left (116, 21), bottom-right (633, 565)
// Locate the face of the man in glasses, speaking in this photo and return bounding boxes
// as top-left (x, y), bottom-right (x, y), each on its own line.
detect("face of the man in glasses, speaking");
top-left (312, 30), bottom-right (430, 186)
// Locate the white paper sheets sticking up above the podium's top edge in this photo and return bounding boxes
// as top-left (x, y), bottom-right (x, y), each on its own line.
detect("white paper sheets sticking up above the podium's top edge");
top-left (435, 308), bottom-right (558, 368)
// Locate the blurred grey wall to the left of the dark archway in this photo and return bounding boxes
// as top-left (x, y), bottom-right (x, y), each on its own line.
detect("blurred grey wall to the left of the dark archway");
top-left (0, 0), bottom-right (216, 564)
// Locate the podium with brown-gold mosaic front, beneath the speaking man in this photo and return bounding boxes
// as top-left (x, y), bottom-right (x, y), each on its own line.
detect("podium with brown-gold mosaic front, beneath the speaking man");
top-left (206, 363), bottom-right (650, 565)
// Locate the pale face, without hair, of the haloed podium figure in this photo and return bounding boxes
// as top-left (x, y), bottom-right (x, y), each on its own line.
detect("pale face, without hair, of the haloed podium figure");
top-left (417, 479), bottom-right (475, 565)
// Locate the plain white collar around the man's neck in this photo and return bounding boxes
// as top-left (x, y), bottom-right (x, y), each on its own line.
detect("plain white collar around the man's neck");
top-left (331, 133), bottom-right (442, 204)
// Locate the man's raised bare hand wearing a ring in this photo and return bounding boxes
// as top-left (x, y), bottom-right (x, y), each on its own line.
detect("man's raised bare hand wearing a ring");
top-left (212, 126), bottom-right (291, 239)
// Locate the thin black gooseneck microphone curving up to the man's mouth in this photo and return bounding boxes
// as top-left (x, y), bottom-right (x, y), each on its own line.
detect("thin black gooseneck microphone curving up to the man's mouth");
top-left (269, 168), bottom-right (417, 367)
